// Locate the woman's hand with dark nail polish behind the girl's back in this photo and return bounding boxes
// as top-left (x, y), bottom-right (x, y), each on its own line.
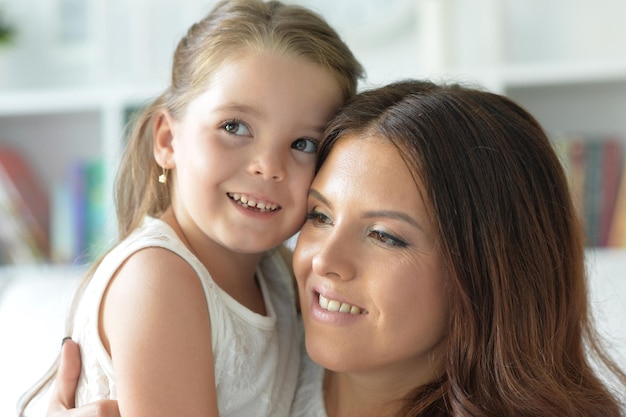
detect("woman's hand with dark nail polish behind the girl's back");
top-left (46, 339), bottom-right (120, 417)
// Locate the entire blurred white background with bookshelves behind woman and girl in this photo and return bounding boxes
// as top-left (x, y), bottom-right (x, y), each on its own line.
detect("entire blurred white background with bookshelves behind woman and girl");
top-left (0, 0), bottom-right (626, 416)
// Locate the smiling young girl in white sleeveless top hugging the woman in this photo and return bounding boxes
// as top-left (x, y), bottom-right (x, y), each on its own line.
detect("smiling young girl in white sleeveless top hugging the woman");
top-left (20, 0), bottom-right (362, 417)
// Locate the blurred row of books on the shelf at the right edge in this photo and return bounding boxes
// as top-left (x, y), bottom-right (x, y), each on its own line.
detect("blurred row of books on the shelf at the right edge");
top-left (554, 135), bottom-right (626, 247)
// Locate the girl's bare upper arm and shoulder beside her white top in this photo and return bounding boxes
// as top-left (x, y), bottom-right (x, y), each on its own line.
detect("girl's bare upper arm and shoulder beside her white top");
top-left (100, 248), bottom-right (218, 417)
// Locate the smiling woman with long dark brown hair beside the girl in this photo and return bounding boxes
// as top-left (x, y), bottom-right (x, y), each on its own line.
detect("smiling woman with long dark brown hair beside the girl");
top-left (49, 81), bottom-right (626, 417)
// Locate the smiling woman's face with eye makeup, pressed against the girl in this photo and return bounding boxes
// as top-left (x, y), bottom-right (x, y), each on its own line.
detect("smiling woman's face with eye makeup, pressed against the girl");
top-left (294, 135), bottom-right (448, 384)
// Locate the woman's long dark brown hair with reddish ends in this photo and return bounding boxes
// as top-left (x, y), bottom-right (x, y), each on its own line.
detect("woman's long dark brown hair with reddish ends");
top-left (318, 81), bottom-right (626, 417)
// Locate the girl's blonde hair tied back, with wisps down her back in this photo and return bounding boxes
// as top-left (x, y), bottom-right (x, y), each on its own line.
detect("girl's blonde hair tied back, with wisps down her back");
top-left (17, 0), bottom-right (364, 416)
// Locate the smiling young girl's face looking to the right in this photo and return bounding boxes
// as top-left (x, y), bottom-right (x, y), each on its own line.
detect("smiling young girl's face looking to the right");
top-left (156, 51), bottom-right (343, 253)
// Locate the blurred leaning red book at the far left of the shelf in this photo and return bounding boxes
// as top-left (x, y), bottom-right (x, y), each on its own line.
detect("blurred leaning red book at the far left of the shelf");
top-left (0, 145), bottom-right (50, 264)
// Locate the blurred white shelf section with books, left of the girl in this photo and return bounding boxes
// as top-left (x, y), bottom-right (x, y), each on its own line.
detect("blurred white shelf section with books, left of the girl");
top-left (0, 87), bottom-right (158, 266)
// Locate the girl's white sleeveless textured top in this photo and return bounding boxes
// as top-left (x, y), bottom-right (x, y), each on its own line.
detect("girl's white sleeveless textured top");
top-left (72, 217), bottom-right (300, 417)
